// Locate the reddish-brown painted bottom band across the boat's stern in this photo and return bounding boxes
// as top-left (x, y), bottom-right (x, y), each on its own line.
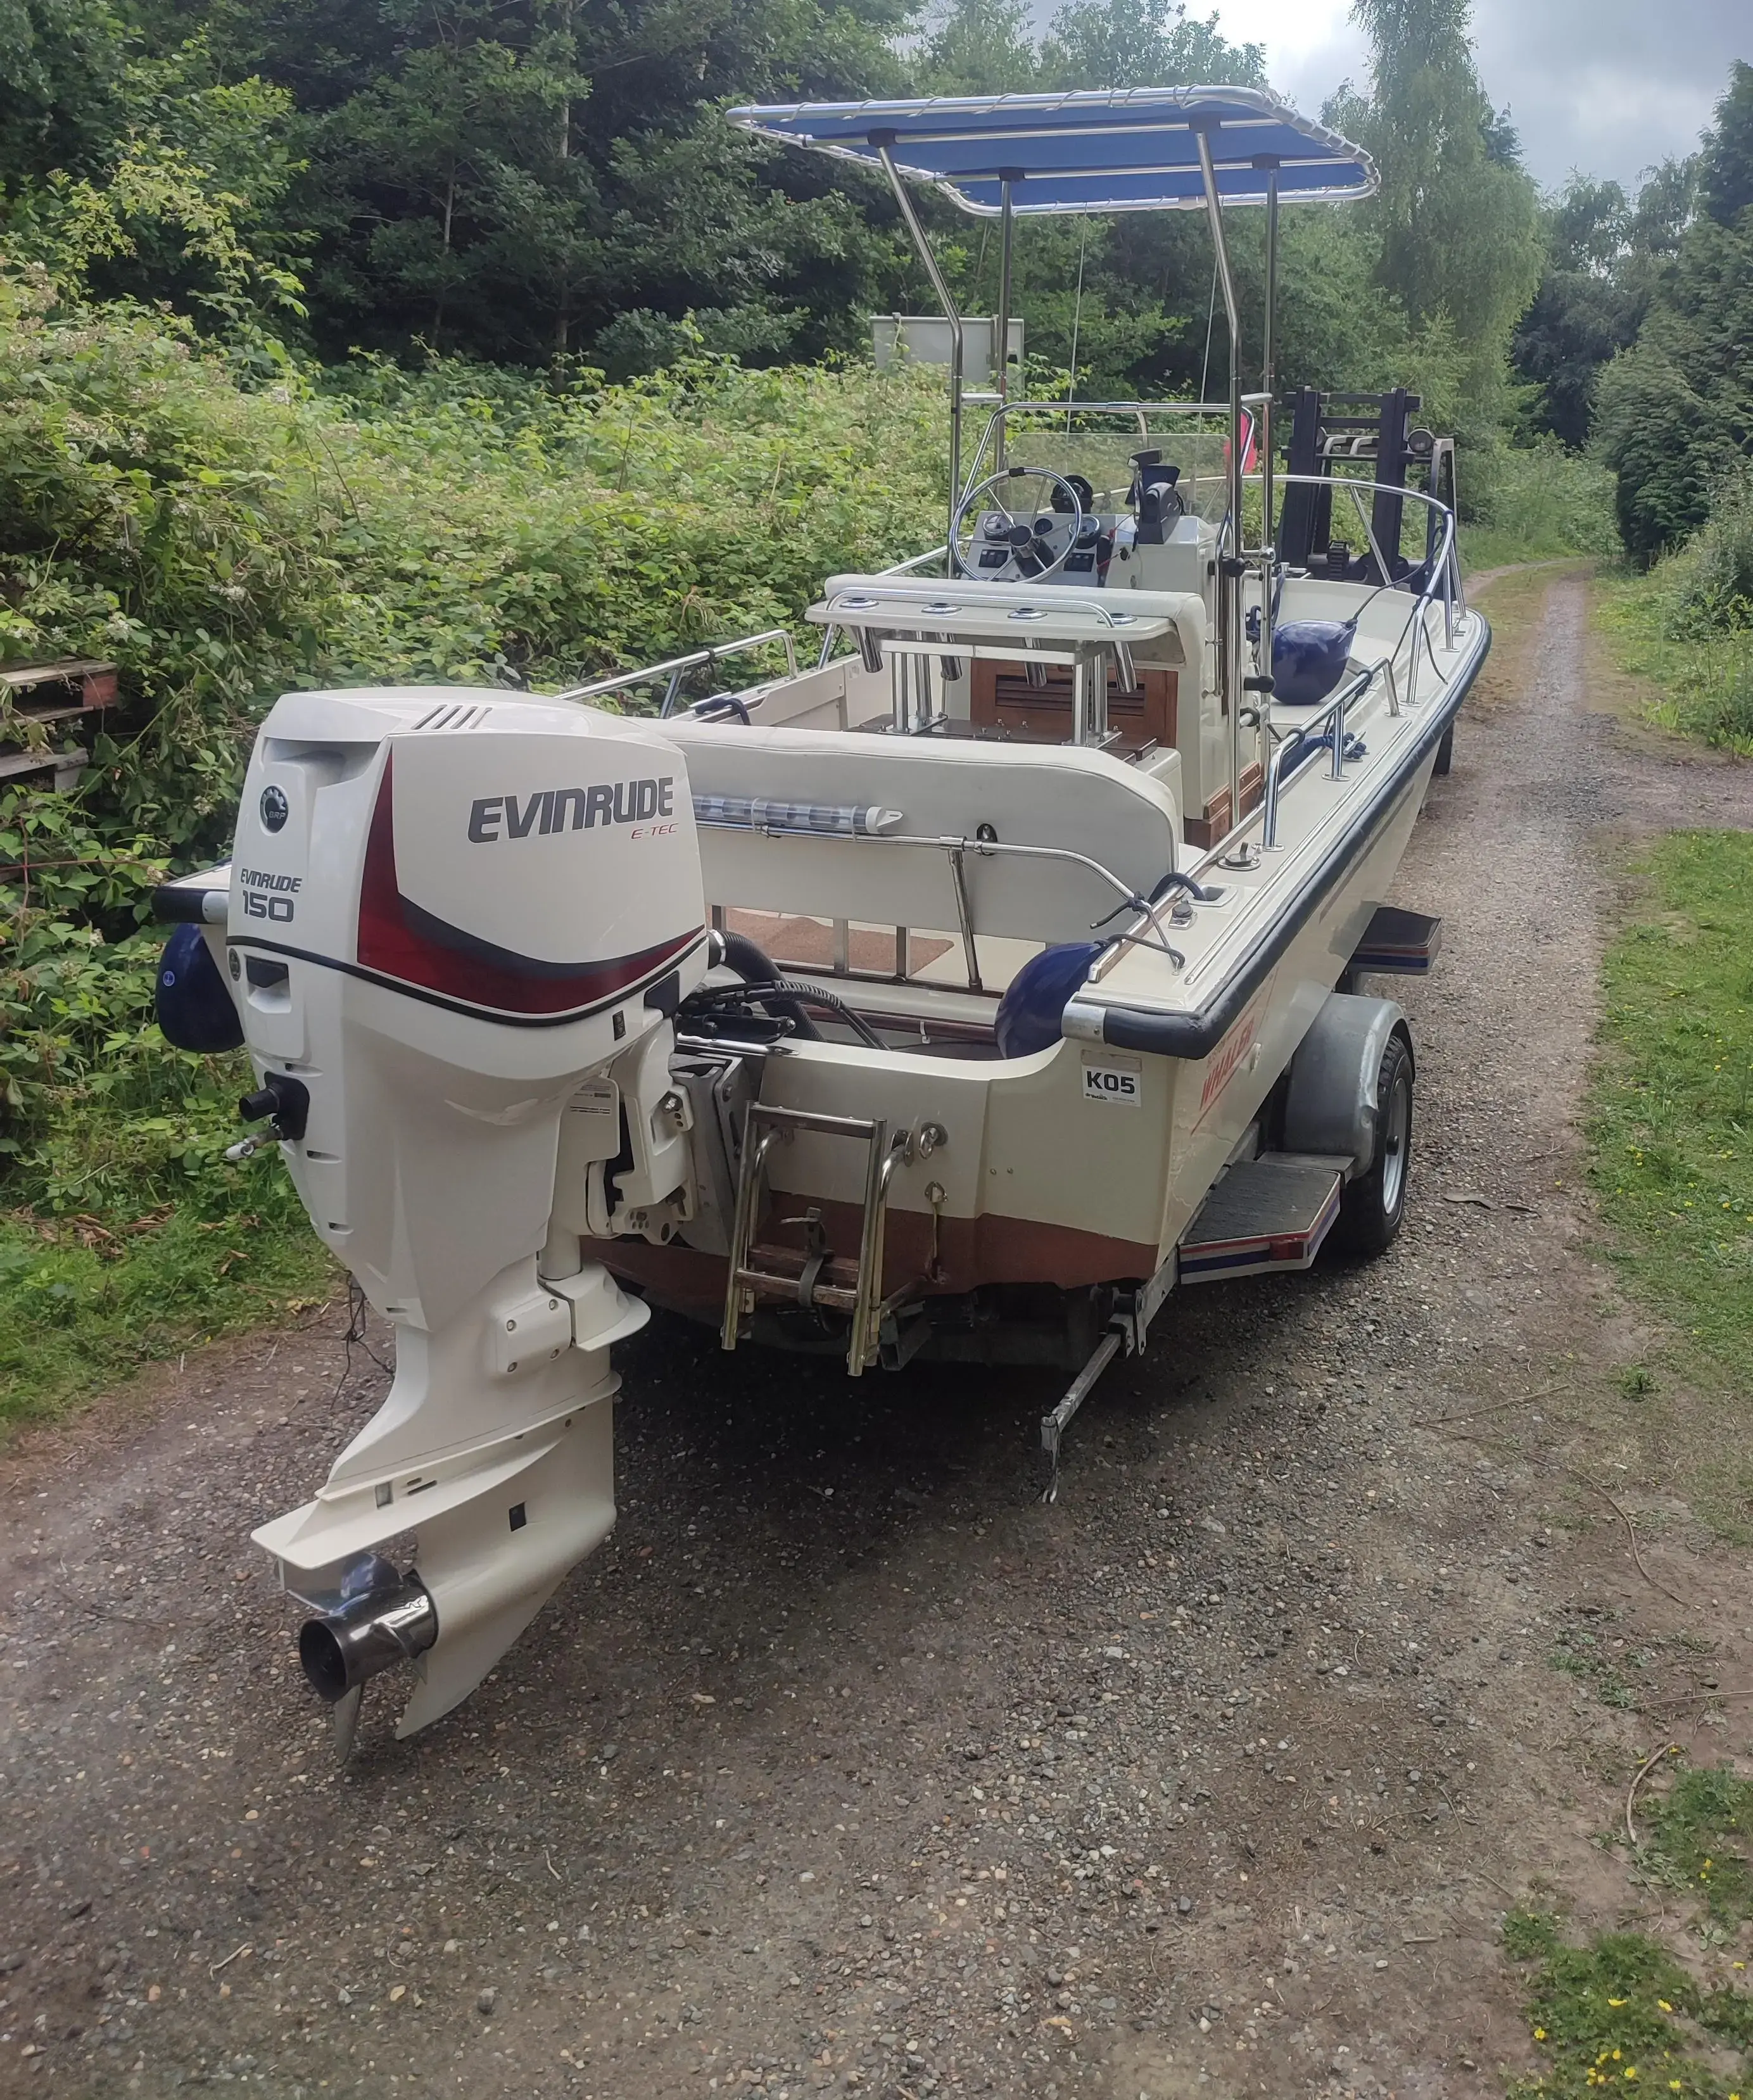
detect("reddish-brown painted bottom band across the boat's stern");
top-left (590, 1195), bottom-right (1157, 1321)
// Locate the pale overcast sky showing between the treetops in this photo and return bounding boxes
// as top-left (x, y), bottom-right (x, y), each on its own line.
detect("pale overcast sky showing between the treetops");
top-left (1188, 0), bottom-right (1753, 189)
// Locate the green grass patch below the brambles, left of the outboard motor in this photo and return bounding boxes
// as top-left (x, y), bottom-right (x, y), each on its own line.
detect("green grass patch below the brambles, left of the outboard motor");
top-left (0, 1161), bottom-right (338, 1430)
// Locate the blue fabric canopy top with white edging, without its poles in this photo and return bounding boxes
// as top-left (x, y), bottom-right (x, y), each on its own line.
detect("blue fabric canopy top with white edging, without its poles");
top-left (728, 88), bottom-right (1377, 218)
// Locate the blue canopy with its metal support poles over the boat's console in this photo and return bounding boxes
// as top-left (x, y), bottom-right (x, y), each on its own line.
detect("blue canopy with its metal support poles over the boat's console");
top-left (728, 86), bottom-right (1377, 869)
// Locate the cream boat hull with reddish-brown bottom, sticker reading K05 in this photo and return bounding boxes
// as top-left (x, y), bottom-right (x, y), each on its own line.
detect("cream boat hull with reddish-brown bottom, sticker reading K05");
top-left (600, 752), bottom-right (1434, 1361)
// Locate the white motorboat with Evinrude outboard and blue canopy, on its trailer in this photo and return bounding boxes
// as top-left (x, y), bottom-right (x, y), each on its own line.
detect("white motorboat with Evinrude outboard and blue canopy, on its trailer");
top-left (160, 88), bottom-right (1488, 1741)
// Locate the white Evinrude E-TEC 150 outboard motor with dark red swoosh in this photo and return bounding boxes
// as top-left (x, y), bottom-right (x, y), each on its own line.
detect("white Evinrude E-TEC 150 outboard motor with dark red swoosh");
top-left (187, 689), bottom-right (706, 1736)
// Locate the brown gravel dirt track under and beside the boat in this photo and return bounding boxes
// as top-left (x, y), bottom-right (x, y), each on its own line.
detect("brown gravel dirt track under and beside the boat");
top-left (0, 573), bottom-right (1753, 2100)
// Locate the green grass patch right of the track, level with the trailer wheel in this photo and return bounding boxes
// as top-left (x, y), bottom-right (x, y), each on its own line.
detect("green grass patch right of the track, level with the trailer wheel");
top-left (1587, 832), bottom-right (1753, 1537)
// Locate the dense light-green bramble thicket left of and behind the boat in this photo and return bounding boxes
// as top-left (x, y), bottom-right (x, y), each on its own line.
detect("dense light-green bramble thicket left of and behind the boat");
top-left (0, 277), bottom-right (945, 1175)
